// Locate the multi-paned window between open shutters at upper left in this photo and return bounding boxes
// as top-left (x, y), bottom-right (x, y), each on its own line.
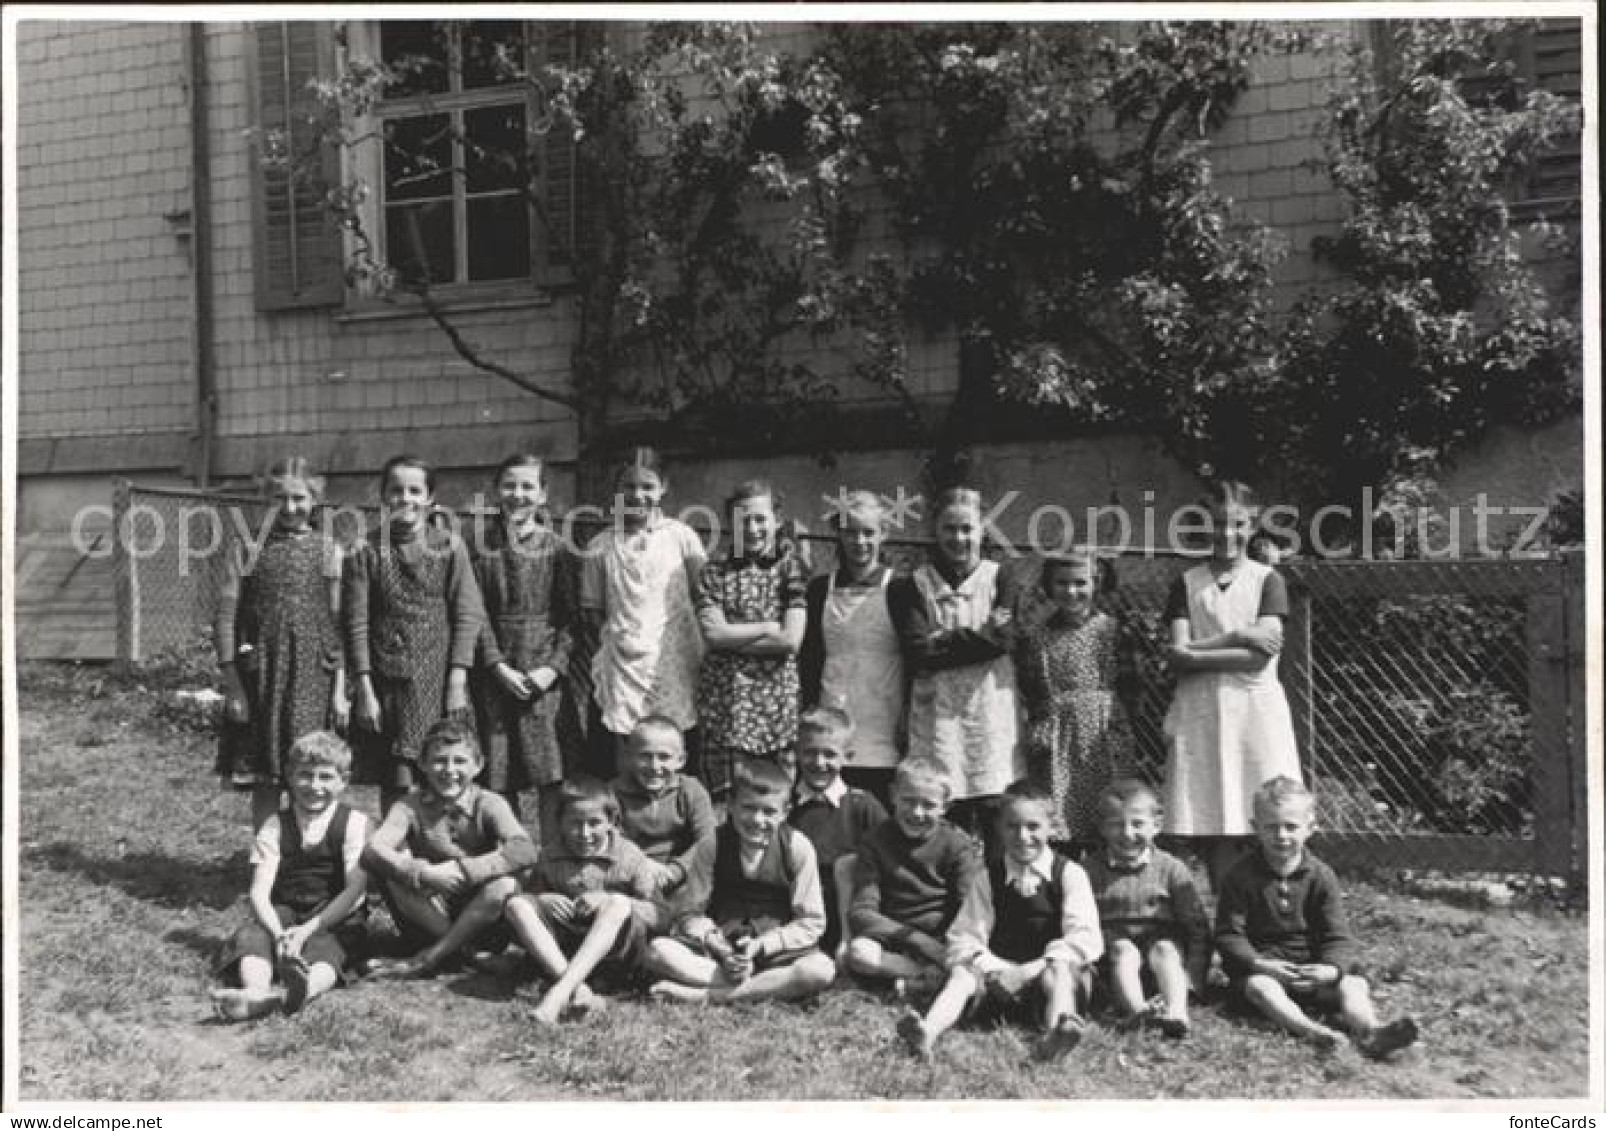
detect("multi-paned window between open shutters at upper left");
top-left (353, 21), bottom-right (597, 288)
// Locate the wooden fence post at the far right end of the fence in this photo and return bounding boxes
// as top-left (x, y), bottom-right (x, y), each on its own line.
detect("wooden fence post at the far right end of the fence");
top-left (1526, 557), bottom-right (1584, 876)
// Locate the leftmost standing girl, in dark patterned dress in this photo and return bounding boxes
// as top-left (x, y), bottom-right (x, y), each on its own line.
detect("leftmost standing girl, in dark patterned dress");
top-left (215, 456), bottom-right (347, 831)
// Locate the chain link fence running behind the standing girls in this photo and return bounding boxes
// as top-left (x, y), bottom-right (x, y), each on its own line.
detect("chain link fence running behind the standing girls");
top-left (114, 482), bottom-right (1587, 876)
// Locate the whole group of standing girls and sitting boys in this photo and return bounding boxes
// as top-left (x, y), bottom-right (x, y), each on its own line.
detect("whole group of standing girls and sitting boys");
top-left (214, 450), bottom-right (1415, 1057)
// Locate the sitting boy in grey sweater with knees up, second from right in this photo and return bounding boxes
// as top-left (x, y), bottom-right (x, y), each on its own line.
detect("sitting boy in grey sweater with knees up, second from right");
top-left (1082, 778), bottom-right (1211, 1041)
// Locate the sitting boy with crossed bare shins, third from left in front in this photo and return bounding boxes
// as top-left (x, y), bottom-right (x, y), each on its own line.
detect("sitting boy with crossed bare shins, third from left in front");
top-left (503, 778), bottom-right (671, 1025)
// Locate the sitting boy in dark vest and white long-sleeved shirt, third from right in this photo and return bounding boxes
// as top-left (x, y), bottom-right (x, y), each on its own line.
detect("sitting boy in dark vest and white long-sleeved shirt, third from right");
top-left (898, 781), bottom-right (1103, 1060)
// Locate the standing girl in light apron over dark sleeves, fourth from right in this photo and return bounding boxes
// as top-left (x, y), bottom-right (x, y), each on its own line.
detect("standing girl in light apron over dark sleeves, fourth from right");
top-left (798, 492), bottom-right (907, 806)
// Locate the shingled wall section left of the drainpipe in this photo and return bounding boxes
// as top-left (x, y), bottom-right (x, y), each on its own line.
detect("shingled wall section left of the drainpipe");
top-left (16, 19), bottom-right (194, 458)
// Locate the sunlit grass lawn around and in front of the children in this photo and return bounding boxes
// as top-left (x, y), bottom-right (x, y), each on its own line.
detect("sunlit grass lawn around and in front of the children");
top-left (9, 665), bottom-right (1588, 1100)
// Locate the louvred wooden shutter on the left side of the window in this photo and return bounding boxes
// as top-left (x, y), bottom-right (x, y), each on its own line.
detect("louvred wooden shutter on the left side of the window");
top-left (249, 21), bottom-right (345, 310)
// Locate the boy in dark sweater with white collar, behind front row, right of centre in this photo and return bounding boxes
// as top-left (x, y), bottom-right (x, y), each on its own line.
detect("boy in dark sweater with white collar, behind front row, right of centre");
top-left (787, 707), bottom-right (887, 956)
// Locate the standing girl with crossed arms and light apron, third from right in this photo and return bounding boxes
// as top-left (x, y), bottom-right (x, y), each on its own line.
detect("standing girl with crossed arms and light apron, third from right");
top-left (887, 487), bottom-right (1021, 845)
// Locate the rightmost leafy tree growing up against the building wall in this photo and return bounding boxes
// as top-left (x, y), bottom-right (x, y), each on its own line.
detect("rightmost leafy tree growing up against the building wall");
top-left (1277, 21), bottom-right (1580, 498)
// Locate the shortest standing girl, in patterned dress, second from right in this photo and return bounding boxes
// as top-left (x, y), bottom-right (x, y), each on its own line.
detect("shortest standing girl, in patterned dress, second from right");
top-left (1015, 551), bottom-right (1135, 845)
